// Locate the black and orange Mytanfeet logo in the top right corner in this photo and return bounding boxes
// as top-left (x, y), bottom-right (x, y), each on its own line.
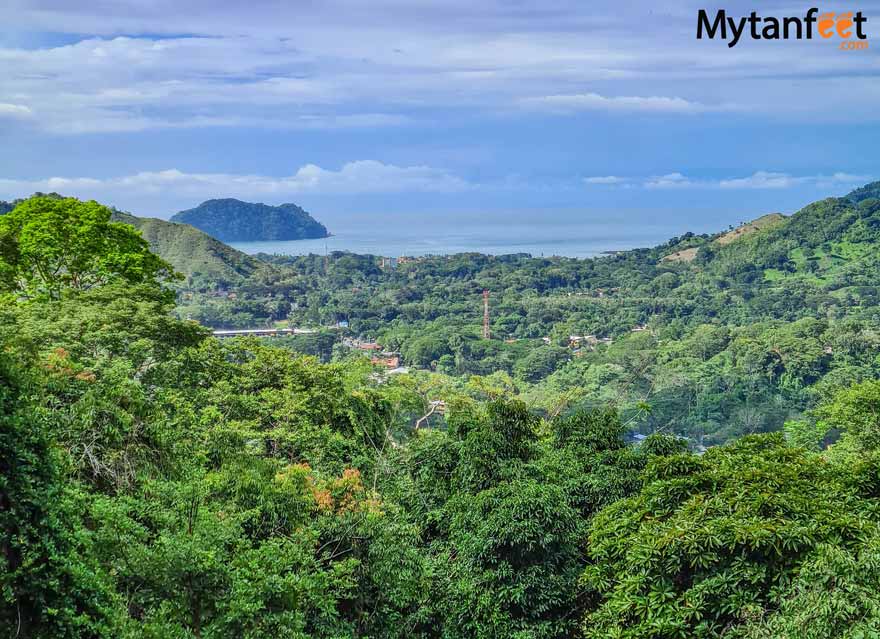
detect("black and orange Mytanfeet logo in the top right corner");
top-left (697, 7), bottom-right (868, 50)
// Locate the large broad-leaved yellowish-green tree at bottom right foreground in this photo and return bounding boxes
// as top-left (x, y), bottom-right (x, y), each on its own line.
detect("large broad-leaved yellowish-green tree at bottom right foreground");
top-left (583, 435), bottom-right (872, 637)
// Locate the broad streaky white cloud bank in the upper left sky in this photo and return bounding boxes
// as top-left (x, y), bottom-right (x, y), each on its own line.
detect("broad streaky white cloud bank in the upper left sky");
top-left (0, 37), bottom-right (410, 134)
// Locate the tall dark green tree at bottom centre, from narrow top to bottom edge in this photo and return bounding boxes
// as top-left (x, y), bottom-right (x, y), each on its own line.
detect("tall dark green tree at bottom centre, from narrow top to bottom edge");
top-left (430, 400), bottom-right (582, 639)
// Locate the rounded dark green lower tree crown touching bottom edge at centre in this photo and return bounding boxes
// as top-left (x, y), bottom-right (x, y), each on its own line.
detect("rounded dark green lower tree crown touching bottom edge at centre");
top-left (438, 478), bottom-right (581, 639)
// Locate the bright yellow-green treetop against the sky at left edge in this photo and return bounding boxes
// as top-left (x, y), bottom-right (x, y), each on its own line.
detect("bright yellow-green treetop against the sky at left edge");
top-left (0, 196), bottom-right (174, 299)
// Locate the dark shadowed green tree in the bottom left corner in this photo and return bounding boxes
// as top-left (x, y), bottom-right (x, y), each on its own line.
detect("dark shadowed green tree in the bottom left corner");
top-left (0, 355), bottom-right (121, 639)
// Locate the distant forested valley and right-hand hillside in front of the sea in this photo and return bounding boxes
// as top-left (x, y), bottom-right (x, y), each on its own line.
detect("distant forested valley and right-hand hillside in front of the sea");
top-left (155, 185), bottom-right (880, 445)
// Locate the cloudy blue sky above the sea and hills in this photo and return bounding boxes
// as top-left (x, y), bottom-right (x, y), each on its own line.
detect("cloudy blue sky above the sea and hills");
top-left (0, 0), bottom-right (880, 228)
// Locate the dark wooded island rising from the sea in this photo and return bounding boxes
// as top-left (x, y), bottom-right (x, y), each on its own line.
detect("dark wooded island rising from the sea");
top-left (171, 198), bottom-right (329, 242)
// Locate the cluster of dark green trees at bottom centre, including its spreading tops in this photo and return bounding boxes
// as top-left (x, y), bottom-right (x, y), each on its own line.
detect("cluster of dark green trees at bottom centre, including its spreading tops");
top-left (382, 400), bottom-right (680, 638)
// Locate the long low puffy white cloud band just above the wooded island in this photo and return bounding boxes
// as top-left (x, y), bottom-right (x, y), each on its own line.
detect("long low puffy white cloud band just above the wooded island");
top-left (0, 160), bottom-right (471, 202)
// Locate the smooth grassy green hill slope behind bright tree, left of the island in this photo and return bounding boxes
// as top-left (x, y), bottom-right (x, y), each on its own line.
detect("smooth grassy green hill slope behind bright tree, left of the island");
top-left (113, 211), bottom-right (262, 286)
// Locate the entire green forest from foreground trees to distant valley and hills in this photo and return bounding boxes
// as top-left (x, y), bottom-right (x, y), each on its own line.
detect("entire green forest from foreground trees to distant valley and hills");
top-left (8, 188), bottom-right (880, 639)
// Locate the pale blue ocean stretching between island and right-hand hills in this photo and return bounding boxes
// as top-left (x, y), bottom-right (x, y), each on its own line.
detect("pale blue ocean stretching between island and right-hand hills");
top-left (230, 211), bottom-right (723, 257)
